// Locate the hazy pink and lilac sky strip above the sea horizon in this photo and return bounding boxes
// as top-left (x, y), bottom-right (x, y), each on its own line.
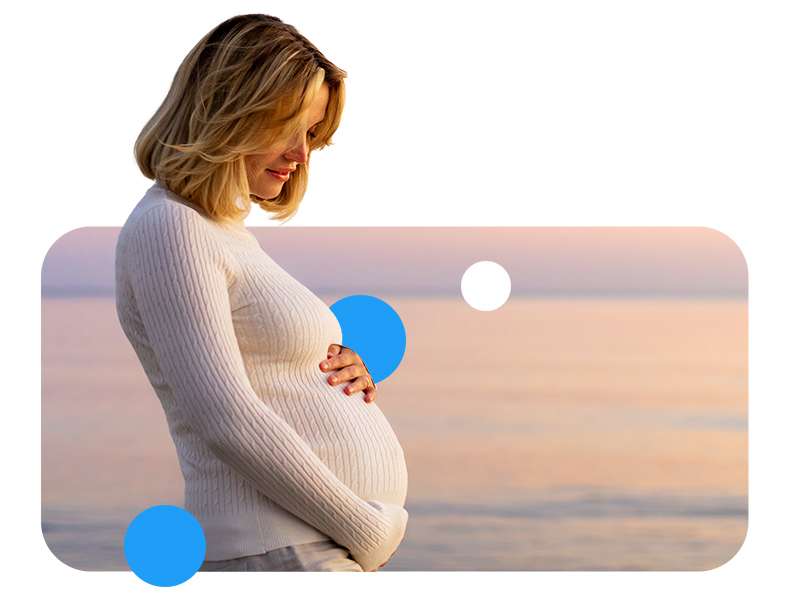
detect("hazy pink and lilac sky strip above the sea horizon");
top-left (42, 227), bottom-right (747, 297)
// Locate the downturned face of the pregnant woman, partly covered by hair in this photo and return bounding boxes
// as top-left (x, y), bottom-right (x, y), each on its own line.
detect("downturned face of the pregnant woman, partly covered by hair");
top-left (244, 83), bottom-right (329, 200)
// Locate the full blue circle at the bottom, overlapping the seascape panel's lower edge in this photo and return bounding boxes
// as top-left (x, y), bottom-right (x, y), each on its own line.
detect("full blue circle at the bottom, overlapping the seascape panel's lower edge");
top-left (125, 505), bottom-right (206, 587)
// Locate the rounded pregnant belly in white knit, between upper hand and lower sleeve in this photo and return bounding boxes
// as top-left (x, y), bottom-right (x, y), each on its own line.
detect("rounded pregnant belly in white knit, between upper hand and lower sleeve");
top-left (266, 373), bottom-right (408, 505)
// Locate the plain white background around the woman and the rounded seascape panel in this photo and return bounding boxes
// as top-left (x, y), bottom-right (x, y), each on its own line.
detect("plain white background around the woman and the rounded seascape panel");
top-left (0, 0), bottom-right (800, 598)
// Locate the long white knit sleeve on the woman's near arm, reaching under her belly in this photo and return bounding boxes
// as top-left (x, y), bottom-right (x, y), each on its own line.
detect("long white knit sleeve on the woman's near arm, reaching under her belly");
top-left (122, 206), bottom-right (408, 571)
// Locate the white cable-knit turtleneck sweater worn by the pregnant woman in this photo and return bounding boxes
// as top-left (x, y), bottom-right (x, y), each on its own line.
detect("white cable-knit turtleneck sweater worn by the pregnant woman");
top-left (116, 185), bottom-right (408, 571)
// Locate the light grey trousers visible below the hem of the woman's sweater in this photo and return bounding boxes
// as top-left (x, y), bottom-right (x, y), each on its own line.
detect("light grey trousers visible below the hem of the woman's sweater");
top-left (200, 540), bottom-right (363, 571)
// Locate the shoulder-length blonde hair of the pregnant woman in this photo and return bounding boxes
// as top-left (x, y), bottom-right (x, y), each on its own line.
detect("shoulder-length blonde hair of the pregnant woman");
top-left (134, 15), bottom-right (347, 220)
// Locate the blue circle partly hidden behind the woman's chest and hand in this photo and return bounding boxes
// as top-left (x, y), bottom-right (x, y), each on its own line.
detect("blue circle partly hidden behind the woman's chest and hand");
top-left (331, 296), bottom-right (406, 383)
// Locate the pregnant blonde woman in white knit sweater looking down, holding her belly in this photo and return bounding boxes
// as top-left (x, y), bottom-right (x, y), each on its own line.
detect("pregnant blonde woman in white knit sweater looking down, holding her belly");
top-left (116, 15), bottom-right (408, 571)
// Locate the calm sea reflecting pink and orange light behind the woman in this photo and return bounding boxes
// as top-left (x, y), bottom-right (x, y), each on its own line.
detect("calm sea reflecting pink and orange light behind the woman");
top-left (42, 298), bottom-right (747, 570)
